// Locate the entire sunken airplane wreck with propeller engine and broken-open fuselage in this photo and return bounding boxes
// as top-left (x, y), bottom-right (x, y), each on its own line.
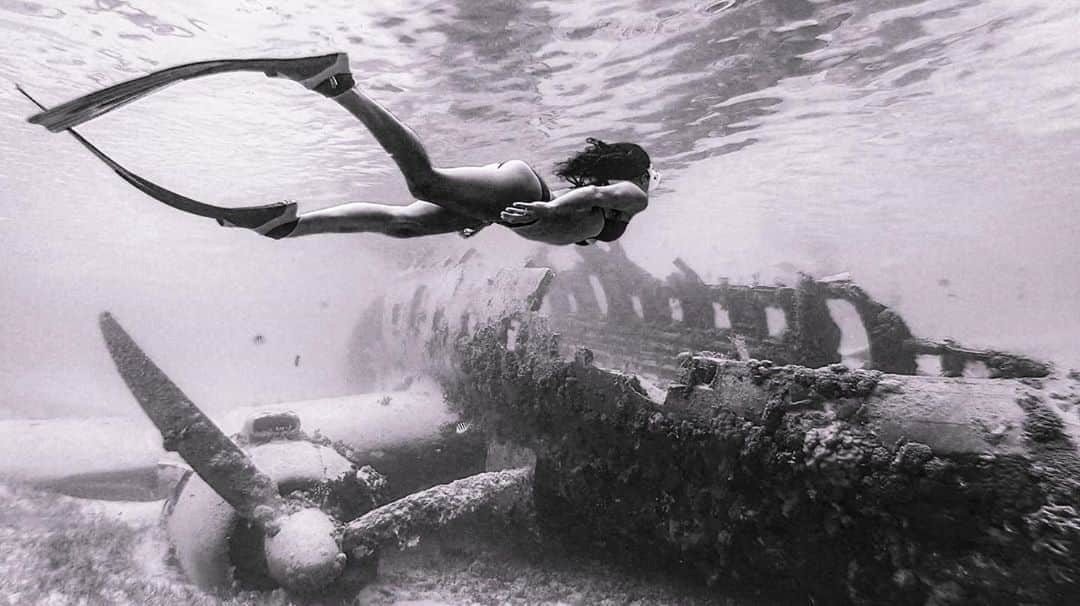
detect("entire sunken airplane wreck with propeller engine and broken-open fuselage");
top-left (95, 246), bottom-right (1080, 604)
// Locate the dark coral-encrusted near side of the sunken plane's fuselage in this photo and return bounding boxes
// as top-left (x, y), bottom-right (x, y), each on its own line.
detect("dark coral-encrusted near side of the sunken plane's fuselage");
top-left (444, 319), bottom-right (1080, 604)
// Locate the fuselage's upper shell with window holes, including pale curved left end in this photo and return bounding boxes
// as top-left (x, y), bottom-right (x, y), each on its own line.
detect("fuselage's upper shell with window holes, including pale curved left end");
top-left (349, 242), bottom-right (1051, 391)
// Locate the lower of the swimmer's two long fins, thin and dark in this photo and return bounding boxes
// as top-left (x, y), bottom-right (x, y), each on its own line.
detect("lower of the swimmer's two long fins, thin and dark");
top-left (16, 86), bottom-right (287, 229)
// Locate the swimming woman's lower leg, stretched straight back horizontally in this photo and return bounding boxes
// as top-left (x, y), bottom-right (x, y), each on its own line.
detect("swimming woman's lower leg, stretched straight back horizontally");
top-left (286, 201), bottom-right (477, 238)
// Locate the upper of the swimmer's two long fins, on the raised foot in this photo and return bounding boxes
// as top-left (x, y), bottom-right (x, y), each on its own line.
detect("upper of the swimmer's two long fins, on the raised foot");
top-left (28, 53), bottom-right (348, 133)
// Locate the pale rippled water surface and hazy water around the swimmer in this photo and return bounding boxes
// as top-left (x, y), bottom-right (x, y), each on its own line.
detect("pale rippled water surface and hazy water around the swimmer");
top-left (0, 0), bottom-right (1080, 412)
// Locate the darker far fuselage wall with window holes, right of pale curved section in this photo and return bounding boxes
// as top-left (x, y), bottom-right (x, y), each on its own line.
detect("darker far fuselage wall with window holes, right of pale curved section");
top-left (534, 243), bottom-right (1050, 379)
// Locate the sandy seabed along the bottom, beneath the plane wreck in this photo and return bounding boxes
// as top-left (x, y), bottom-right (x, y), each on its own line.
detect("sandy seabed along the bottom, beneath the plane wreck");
top-left (0, 484), bottom-right (759, 606)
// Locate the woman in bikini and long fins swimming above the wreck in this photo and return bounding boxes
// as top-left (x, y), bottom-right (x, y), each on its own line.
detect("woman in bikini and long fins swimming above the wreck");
top-left (27, 53), bottom-right (654, 244)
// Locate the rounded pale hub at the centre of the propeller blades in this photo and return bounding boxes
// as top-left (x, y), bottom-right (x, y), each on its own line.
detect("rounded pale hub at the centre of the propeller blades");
top-left (266, 509), bottom-right (347, 592)
